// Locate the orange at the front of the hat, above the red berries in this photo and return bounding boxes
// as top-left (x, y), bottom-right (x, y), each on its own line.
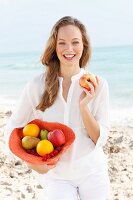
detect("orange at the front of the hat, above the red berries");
top-left (36, 140), bottom-right (54, 156)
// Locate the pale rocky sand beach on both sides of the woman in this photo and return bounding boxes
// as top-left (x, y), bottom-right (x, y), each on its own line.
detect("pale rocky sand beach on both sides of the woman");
top-left (0, 106), bottom-right (133, 200)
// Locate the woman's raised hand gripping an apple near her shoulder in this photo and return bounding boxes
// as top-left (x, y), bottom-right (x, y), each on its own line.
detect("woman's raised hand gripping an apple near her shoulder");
top-left (79, 76), bottom-right (99, 107)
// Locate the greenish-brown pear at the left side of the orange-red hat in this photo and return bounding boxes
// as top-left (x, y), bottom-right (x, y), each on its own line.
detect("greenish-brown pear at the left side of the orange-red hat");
top-left (22, 136), bottom-right (40, 149)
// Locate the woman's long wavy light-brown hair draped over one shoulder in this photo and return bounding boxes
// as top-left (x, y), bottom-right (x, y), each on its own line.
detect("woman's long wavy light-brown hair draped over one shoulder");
top-left (36, 16), bottom-right (91, 111)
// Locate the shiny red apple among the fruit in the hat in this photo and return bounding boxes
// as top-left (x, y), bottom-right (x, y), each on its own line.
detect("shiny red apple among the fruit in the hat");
top-left (48, 129), bottom-right (66, 147)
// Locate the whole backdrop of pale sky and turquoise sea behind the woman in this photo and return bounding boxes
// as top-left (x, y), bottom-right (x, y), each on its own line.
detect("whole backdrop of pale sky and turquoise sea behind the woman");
top-left (0, 0), bottom-right (133, 126)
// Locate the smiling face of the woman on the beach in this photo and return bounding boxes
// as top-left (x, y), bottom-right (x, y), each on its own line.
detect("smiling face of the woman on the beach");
top-left (56, 25), bottom-right (83, 67)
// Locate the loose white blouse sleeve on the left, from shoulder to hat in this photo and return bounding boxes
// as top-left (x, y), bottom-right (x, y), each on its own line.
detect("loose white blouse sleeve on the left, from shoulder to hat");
top-left (4, 73), bottom-right (45, 146)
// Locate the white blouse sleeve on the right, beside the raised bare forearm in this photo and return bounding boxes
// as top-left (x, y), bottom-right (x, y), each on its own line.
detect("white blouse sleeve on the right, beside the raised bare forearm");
top-left (95, 80), bottom-right (109, 148)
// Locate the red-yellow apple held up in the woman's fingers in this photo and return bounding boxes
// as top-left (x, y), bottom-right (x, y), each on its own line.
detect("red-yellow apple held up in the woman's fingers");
top-left (79, 74), bottom-right (97, 91)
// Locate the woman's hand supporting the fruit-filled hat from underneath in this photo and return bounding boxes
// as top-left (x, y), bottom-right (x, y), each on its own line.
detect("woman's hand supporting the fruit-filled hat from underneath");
top-left (26, 162), bottom-right (56, 174)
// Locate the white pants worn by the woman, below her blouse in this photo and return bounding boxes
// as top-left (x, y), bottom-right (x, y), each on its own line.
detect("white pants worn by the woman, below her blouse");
top-left (37, 172), bottom-right (109, 200)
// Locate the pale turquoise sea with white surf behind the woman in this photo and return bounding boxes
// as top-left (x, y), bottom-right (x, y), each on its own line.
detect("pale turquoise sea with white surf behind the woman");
top-left (0, 45), bottom-right (133, 127)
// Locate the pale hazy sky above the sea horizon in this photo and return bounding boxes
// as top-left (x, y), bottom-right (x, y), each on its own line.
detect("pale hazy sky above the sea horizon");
top-left (0, 0), bottom-right (133, 53)
